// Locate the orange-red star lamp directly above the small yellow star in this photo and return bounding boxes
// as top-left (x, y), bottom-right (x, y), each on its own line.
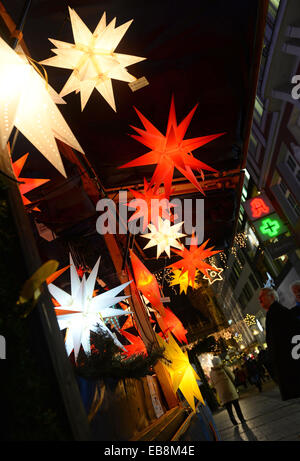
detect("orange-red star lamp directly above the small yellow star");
top-left (167, 236), bottom-right (220, 287)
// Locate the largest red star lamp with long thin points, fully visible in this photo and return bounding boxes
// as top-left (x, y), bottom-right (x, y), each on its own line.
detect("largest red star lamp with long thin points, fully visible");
top-left (119, 96), bottom-right (225, 197)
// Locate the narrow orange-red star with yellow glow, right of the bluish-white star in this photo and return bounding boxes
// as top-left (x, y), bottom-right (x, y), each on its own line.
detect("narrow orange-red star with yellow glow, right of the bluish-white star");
top-left (129, 250), bottom-right (164, 316)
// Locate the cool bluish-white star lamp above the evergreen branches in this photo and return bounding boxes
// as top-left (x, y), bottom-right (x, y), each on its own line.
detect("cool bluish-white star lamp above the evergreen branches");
top-left (48, 255), bottom-right (131, 360)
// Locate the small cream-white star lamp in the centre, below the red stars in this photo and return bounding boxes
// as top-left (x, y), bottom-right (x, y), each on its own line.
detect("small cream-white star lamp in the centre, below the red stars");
top-left (141, 216), bottom-right (186, 258)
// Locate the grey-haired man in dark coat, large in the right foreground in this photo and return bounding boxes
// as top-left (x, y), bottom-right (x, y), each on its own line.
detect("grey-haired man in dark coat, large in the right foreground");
top-left (259, 288), bottom-right (300, 400)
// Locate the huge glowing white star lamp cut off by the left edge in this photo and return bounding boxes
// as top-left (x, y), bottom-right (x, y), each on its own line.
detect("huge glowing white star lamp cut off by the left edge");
top-left (0, 38), bottom-right (84, 176)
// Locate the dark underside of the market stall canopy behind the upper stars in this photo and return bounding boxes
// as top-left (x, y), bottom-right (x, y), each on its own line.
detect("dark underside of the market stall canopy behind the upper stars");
top-left (1, 0), bottom-right (267, 256)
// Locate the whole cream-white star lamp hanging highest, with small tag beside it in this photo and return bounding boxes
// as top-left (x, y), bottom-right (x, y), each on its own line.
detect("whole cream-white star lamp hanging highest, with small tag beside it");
top-left (41, 7), bottom-right (146, 111)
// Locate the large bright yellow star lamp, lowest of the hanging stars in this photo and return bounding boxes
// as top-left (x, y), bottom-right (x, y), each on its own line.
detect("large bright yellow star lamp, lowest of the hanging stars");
top-left (156, 334), bottom-right (204, 411)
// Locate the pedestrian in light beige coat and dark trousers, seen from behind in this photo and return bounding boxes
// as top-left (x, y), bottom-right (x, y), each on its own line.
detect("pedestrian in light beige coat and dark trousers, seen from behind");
top-left (210, 357), bottom-right (245, 426)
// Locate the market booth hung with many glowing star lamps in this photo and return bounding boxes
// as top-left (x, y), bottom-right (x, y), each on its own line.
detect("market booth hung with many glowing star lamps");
top-left (0, 0), bottom-right (267, 441)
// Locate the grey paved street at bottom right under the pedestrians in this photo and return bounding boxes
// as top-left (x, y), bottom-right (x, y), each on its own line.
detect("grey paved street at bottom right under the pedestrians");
top-left (214, 381), bottom-right (300, 442)
